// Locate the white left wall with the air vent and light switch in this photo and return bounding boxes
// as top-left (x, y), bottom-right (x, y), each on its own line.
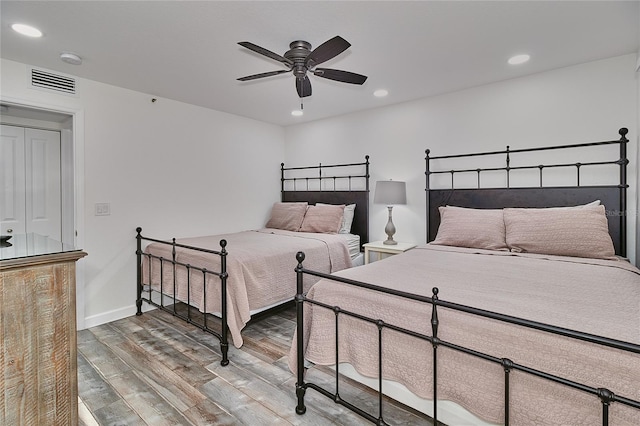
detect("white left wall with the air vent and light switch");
top-left (0, 60), bottom-right (284, 327)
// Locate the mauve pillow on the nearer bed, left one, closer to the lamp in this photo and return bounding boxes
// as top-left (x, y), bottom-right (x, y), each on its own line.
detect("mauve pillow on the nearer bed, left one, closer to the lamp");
top-left (431, 206), bottom-right (509, 251)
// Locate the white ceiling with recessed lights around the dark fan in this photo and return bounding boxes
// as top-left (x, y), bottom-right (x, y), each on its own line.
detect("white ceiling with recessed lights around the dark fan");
top-left (0, 0), bottom-right (640, 126)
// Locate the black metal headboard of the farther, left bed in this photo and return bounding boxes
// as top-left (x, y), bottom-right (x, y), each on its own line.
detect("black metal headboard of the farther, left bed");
top-left (280, 155), bottom-right (369, 250)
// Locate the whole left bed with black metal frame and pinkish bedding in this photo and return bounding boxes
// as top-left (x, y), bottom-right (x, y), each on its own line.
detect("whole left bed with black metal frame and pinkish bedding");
top-left (136, 156), bottom-right (369, 365)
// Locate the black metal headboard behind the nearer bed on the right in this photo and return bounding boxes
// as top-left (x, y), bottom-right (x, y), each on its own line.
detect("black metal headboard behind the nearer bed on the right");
top-left (425, 128), bottom-right (629, 256)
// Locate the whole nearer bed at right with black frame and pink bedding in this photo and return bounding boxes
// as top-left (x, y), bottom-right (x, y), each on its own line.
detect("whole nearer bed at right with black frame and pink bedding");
top-left (289, 129), bottom-right (640, 426)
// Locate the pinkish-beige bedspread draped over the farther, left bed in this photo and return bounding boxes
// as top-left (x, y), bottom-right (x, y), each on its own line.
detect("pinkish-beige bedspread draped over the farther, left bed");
top-left (142, 229), bottom-right (351, 347)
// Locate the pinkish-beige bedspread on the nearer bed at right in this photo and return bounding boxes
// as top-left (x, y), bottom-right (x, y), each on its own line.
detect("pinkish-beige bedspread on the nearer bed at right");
top-left (289, 245), bottom-right (640, 426)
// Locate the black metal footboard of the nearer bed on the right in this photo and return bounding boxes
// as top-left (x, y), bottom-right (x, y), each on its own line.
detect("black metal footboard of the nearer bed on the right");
top-left (295, 252), bottom-right (640, 425)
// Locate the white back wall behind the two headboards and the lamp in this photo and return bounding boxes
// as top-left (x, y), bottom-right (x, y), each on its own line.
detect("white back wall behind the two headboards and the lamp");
top-left (285, 54), bottom-right (638, 259)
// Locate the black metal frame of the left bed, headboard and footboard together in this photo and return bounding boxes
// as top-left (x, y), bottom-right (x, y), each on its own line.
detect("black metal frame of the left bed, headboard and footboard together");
top-left (136, 155), bottom-right (369, 366)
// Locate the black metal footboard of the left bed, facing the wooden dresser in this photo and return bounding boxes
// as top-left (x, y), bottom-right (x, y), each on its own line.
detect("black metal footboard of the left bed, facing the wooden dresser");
top-left (136, 228), bottom-right (229, 366)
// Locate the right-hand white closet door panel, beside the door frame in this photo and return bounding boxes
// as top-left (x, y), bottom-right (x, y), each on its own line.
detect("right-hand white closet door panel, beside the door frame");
top-left (25, 129), bottom-right (62, 241)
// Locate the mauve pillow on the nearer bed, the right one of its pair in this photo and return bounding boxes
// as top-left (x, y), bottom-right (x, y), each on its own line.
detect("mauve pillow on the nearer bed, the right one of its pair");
top-left (504, 205), bottom-right (615, 259)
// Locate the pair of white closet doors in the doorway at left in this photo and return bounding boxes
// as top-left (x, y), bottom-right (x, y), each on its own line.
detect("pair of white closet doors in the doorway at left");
top-left (0, 126), bottom-right (62, 241)
